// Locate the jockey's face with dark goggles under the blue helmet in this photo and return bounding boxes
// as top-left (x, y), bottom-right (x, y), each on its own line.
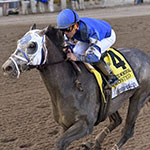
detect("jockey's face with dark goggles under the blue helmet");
top-left (64, 23), bottom-right (79, 38)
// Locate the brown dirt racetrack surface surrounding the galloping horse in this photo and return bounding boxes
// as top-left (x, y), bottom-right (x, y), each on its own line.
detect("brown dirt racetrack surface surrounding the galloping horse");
top-left (0, 6), bottom-right (150, 150)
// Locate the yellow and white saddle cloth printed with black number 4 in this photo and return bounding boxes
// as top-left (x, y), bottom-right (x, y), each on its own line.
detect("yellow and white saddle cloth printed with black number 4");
top-left (86, 48), bottom-right (139, 102)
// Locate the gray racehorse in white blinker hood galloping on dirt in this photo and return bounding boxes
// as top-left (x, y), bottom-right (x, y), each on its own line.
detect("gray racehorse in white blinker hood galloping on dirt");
top-left (2, 26), bottom-right (150, 150)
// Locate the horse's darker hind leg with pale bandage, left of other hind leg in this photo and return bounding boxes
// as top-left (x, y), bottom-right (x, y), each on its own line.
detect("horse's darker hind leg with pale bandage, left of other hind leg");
top-left (94, 111), bottom-right (122, 150)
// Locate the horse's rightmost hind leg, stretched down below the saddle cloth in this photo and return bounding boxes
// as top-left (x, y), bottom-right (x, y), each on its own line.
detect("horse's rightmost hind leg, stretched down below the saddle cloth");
top-left (112, 92), bottom-right (147, 150)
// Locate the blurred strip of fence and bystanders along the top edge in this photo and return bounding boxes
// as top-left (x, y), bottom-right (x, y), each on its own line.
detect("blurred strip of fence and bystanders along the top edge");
top-left (0, 0), bottom-right (150, 16)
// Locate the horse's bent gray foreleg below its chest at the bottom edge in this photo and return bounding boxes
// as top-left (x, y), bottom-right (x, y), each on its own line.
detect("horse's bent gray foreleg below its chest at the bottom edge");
top-left (56, 120), bottom-right (92, 150)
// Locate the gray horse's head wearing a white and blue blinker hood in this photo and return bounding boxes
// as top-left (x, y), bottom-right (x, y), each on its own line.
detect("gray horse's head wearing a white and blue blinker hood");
top-left (2, 25), bottom-right (47, 78)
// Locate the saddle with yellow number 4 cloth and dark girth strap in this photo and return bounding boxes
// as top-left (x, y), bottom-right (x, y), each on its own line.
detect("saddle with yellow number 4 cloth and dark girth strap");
top-left (69, 48), bottom-right (139, 125)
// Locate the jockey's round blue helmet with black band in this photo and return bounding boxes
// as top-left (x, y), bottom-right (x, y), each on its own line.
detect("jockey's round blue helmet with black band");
top-left (56, 9), bottom-right (79, 29)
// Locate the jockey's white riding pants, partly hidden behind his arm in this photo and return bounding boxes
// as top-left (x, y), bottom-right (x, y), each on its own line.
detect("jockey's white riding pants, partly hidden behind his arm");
top-left (73, 29), bottom-right (116, 56)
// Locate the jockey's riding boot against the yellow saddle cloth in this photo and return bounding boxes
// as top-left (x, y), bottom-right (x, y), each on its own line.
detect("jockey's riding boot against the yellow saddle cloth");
top-left (95, 59), bottom-right (119, 86)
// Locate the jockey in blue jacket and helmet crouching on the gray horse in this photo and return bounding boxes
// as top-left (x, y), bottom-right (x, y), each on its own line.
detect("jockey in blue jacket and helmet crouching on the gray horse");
top-left (56, 9), bottom-right (118, 86)
